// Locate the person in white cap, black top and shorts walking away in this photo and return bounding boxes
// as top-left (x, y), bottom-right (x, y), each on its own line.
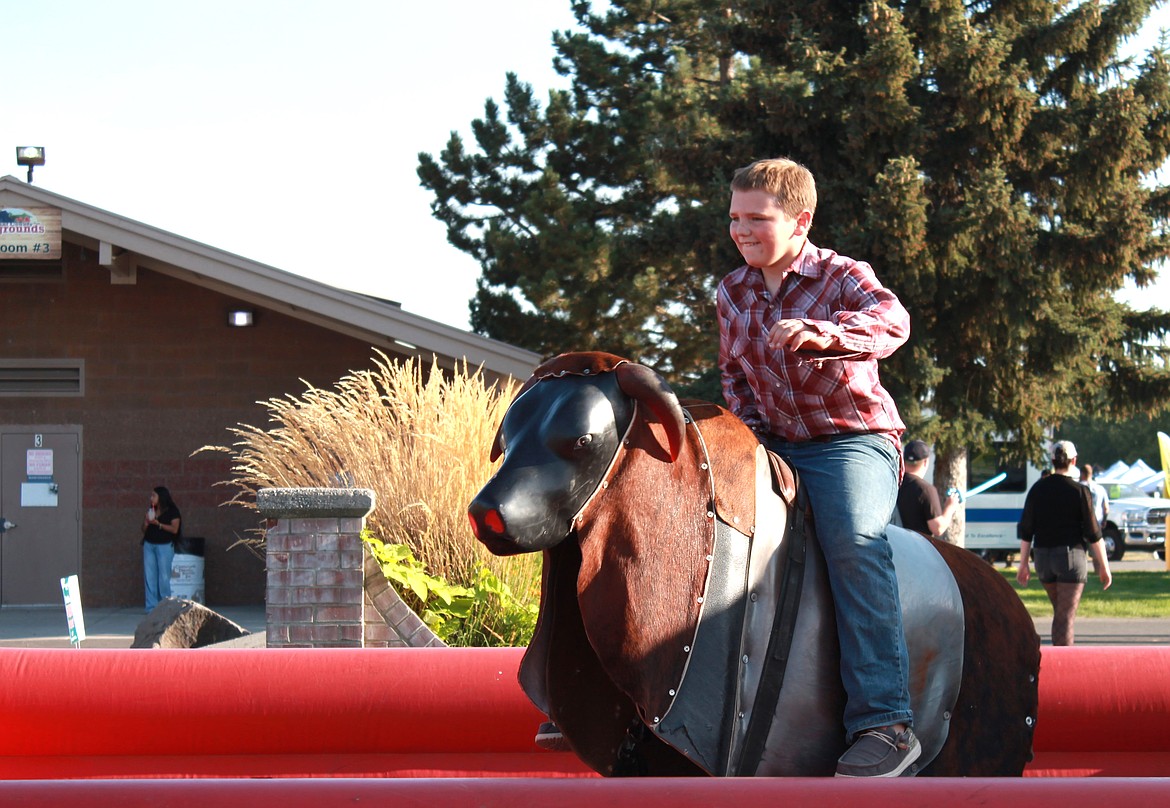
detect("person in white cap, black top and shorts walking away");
top-left (1016, 441), bottom-right (1113, 645)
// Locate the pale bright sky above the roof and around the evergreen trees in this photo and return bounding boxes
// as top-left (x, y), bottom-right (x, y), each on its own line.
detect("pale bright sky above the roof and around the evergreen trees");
top-left (0, 0), bottom-right (1170, 329)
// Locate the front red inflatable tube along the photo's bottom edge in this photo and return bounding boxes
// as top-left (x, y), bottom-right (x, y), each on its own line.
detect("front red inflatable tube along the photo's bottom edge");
top-left (0, 778), bottom-right (1170, 808)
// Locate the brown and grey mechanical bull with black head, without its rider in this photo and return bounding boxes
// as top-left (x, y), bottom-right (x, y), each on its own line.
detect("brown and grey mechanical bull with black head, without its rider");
top-left (468, 353), bottom-right (1040, 776)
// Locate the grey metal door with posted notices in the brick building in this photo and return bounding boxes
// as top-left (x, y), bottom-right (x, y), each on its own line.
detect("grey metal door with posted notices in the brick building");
top-left (0, 427), bottom-right (84, 606)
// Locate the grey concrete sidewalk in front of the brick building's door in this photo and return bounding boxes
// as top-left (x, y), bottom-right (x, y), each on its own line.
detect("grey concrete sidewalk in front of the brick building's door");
top-left (0, 605), bottom-right (267, 648)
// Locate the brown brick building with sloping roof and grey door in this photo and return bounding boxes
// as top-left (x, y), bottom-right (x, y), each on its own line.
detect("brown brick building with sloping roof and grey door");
top-left (0, 177), bottom-right (539, 607)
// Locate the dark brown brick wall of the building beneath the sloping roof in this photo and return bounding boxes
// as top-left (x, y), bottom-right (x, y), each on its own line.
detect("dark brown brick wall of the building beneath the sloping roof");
top-left (0, 243), bottom-right (416, 608)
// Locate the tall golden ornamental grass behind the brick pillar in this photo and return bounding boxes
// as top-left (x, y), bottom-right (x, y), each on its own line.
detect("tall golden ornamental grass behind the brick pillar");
top-left (200, 352), bottom-right (541, 636)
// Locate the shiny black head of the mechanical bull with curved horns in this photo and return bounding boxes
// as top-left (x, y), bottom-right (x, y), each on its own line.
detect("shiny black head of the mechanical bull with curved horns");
top-left (468, 354), bottom-right (683, 555)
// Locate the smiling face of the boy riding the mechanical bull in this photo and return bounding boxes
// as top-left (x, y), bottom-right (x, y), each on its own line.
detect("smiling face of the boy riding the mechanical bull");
top-left (730, 191), bottom-right (812, 271)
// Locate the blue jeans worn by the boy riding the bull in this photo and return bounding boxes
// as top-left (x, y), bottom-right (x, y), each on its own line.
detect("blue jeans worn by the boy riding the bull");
top-left (769, 435), bottom-right (913, 743)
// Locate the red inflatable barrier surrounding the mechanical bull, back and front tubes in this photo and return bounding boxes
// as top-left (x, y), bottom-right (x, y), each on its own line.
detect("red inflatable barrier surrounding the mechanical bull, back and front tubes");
top-left (0, 647), bottom-right (1170, 795)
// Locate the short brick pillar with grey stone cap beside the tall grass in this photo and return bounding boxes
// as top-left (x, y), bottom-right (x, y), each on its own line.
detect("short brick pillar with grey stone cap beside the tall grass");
top-left (256, 489), bottom-right (374, 648)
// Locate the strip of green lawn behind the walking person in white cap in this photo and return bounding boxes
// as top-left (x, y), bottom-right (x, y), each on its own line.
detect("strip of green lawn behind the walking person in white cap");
top-left (1003, 564), bottom-right (1170, 617)
